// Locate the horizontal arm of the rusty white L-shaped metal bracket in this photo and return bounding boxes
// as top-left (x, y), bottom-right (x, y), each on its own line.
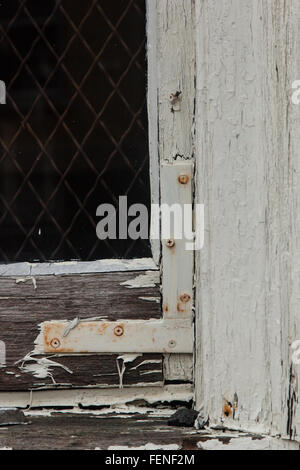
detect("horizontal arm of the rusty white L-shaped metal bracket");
top-left (37, 320), bottom-right (194, 354)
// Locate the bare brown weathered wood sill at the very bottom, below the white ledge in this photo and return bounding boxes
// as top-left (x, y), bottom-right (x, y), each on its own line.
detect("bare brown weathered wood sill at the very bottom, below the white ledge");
top-left (0, 409), bottom-right (199, 450)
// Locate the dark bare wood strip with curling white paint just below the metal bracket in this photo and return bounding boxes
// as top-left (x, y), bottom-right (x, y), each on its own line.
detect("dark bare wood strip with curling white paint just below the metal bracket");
top-left (0, 354), bottom-right (163, 391)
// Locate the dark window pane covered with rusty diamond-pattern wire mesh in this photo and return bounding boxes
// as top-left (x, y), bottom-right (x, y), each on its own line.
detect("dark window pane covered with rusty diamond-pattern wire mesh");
top-left (0, 0), bottom-right (150, 262)
